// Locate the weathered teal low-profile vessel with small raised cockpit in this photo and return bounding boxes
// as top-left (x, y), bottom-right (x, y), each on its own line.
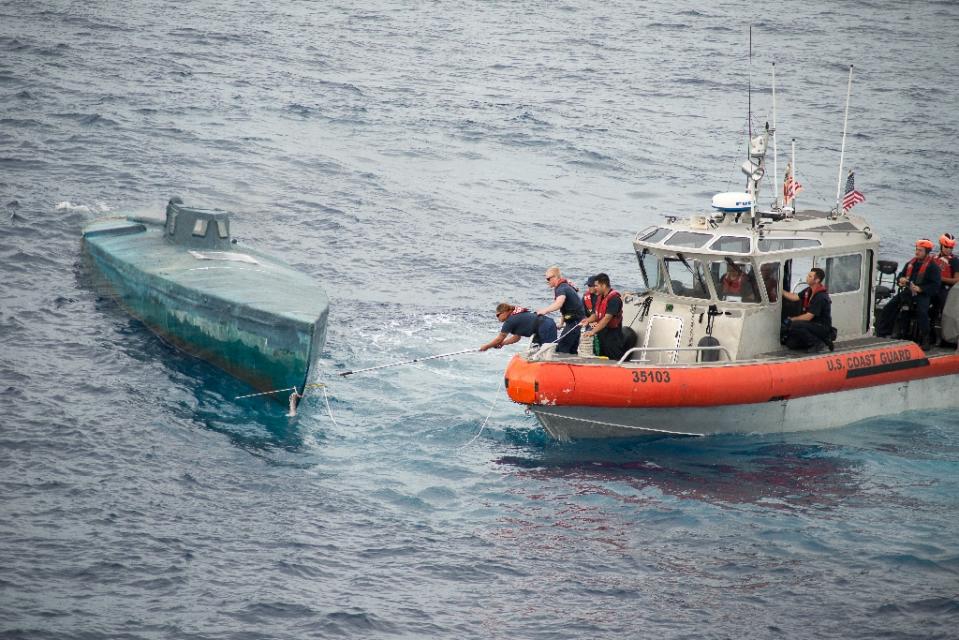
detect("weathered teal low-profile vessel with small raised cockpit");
top-left (83, 198), bottom-right (329, 402)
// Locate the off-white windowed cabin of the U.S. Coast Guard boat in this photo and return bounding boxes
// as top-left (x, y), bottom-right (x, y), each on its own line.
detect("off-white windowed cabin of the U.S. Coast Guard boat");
top-left (623, 208), bottom-right (879, 364)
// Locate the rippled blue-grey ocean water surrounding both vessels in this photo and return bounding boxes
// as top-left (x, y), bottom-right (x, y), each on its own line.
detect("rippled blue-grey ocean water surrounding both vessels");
top-left (0, 0), bottom-right (959, 639)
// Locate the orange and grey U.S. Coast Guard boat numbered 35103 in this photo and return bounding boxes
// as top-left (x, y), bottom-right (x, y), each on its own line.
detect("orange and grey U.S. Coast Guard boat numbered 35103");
top-left (505, 117), bottom-right (959, 440)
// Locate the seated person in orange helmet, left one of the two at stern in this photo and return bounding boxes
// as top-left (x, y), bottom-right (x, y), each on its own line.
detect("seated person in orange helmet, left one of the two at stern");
top-left (876, 238), bottom-right (942, 347)
